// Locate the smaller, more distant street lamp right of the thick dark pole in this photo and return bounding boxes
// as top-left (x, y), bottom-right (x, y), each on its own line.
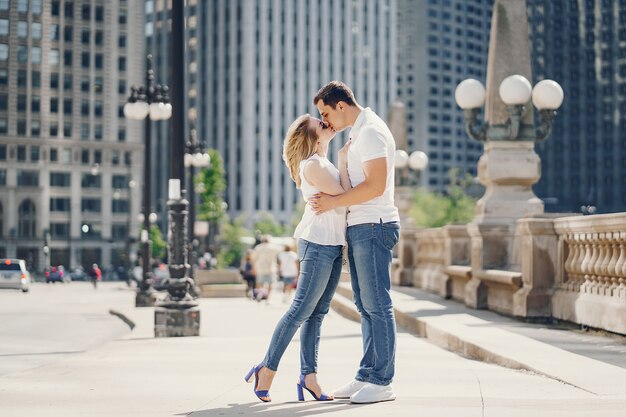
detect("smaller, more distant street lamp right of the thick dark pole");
top-left (185, 129), bottom-right (211, 278)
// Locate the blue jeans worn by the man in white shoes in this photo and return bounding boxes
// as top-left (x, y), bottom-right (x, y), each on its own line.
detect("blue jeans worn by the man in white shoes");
top-left (347, 221), bottom-right (400, 385)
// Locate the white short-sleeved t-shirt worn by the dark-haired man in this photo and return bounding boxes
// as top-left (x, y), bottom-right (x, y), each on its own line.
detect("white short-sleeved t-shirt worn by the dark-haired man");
top-left (348, 107), bottom-right (400, 226)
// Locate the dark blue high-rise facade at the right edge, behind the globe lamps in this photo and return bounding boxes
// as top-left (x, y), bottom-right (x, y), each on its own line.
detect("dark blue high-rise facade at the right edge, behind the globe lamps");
top-left (527, 0), bottom-right (626, 213)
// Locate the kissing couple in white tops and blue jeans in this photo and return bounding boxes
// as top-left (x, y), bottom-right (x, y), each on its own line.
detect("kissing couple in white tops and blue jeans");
top-left (245, 81), bottom-right (400, 404)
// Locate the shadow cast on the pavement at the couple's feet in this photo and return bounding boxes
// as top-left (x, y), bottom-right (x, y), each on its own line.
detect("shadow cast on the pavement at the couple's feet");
top-left (183, 400), bottom-right (363, 417)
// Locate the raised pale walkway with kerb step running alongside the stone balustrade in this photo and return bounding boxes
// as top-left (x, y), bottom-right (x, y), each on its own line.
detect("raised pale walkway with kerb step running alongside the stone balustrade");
top-left (333, 283), bottom-right (626, 394)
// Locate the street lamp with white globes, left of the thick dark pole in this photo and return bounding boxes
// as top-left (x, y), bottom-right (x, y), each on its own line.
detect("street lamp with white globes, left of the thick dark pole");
top-left (124, 55), bottom-right (172, 307)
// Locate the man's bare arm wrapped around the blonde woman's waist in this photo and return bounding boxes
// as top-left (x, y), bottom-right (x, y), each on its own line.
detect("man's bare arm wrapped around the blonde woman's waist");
top-left (309, 157), bottom-right (387, 214)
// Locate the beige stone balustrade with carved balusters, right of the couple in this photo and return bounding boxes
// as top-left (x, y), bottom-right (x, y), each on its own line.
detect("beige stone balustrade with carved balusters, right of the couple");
top-left (410, 213), bottom-right (626, 334)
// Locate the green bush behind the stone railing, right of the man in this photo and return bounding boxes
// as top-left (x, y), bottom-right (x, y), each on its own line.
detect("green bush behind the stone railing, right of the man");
top-left (409, 168), bottom-right (476, 227)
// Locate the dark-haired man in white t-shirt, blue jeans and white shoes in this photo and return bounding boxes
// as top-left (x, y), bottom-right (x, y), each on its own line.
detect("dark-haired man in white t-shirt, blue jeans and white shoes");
top-left (309, 81), bottom-right (400, 404)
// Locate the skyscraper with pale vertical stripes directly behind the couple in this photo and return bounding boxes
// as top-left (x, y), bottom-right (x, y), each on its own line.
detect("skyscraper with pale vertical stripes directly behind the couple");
top-left (146, 0), bottom-right (396, 228)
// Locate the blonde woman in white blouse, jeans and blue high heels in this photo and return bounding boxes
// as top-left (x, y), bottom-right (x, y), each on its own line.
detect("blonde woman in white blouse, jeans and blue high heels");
top-left (245, 114), bottom-right (350, 402)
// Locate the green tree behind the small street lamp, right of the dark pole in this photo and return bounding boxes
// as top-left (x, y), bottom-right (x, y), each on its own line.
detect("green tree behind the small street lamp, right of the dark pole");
top-left (194, 149), bottom-right (226, 223)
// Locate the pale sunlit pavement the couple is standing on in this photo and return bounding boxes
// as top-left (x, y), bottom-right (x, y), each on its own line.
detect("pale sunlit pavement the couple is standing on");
top-left (0, 282), bottom-right (626, 417)
